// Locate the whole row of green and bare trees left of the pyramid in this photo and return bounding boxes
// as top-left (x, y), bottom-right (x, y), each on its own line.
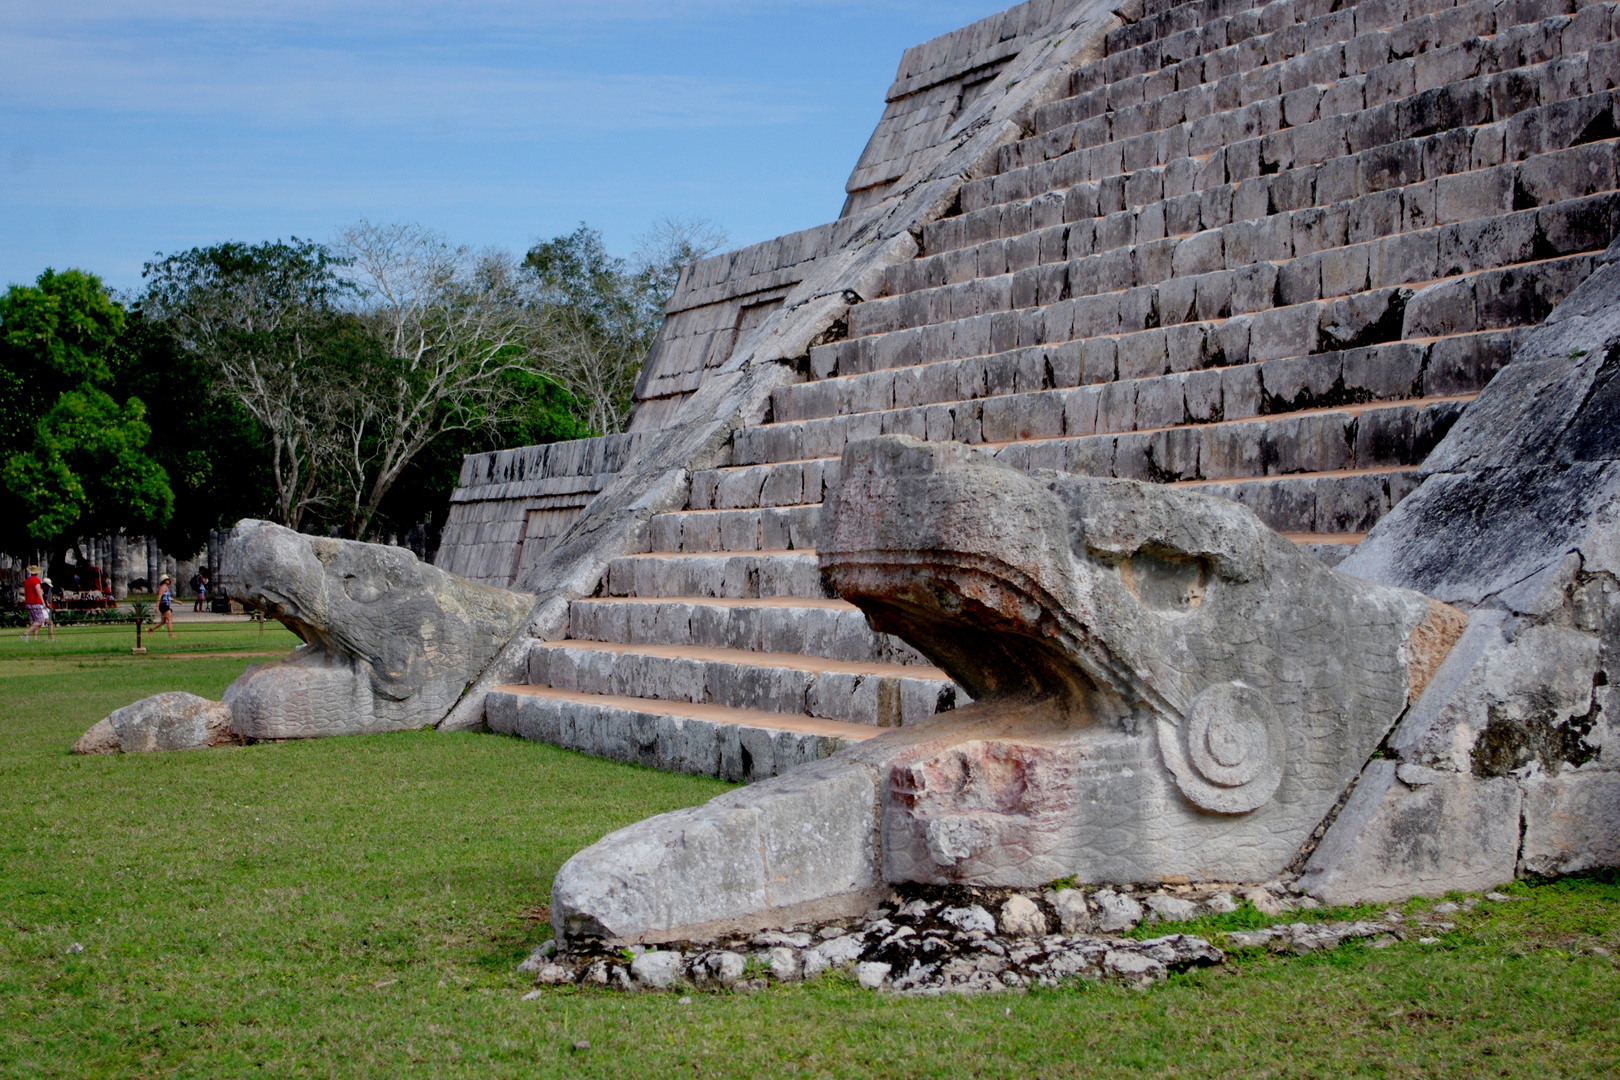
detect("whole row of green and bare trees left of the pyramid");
top-left (0, 222), bottom-right (723, 563)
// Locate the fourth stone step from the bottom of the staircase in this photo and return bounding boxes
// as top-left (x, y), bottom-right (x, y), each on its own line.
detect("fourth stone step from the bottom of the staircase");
top-left (606, 550), bottom-right (838, 599)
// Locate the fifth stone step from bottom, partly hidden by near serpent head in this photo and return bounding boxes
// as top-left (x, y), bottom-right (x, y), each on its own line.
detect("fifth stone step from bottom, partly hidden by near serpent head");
top-left (648, 466), bottom-right (1427, 550)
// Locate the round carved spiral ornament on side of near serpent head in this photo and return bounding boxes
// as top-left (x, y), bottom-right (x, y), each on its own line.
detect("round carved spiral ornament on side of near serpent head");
top-left (1158, 682), bottom-right (1288, 814)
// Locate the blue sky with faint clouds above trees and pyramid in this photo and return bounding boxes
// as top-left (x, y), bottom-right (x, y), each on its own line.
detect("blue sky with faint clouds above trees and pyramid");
top-left (0, 0), bottom-right (1006, 288)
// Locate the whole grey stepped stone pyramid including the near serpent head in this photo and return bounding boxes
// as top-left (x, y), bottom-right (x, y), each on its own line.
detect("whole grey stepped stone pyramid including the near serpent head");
top-left (91, 0), bottom-right (1620, 942)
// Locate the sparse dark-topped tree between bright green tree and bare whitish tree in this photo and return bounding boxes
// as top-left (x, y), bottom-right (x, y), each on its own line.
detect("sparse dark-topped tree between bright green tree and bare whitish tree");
top-left (141, 236), bottom-right (354, 528)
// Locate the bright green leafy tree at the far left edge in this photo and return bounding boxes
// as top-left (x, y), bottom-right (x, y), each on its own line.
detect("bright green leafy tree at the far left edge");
top-left (0, 270), bottom-right (173, 552)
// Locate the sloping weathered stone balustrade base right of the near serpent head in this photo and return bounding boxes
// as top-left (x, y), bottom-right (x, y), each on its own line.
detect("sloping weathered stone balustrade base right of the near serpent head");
top-left (1304, 243), bottom-right (1620, 904)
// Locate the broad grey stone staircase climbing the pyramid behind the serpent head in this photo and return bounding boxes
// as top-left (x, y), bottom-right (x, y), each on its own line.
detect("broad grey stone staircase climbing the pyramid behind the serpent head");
top-left (486, 0), bottom-right (1620, 779)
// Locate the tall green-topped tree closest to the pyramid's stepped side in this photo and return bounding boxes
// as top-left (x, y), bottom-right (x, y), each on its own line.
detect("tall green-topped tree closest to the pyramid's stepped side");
top-left (523, 219), bottom-right (726, 432)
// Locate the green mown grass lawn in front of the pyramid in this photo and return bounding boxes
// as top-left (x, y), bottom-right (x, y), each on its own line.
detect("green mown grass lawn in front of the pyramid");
top-left (0, 623), bottom-right (1620, 1080)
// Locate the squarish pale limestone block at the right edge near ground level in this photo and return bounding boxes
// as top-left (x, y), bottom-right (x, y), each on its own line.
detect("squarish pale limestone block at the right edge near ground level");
top-left (1520, 767), bottom-right (1620, 874)
